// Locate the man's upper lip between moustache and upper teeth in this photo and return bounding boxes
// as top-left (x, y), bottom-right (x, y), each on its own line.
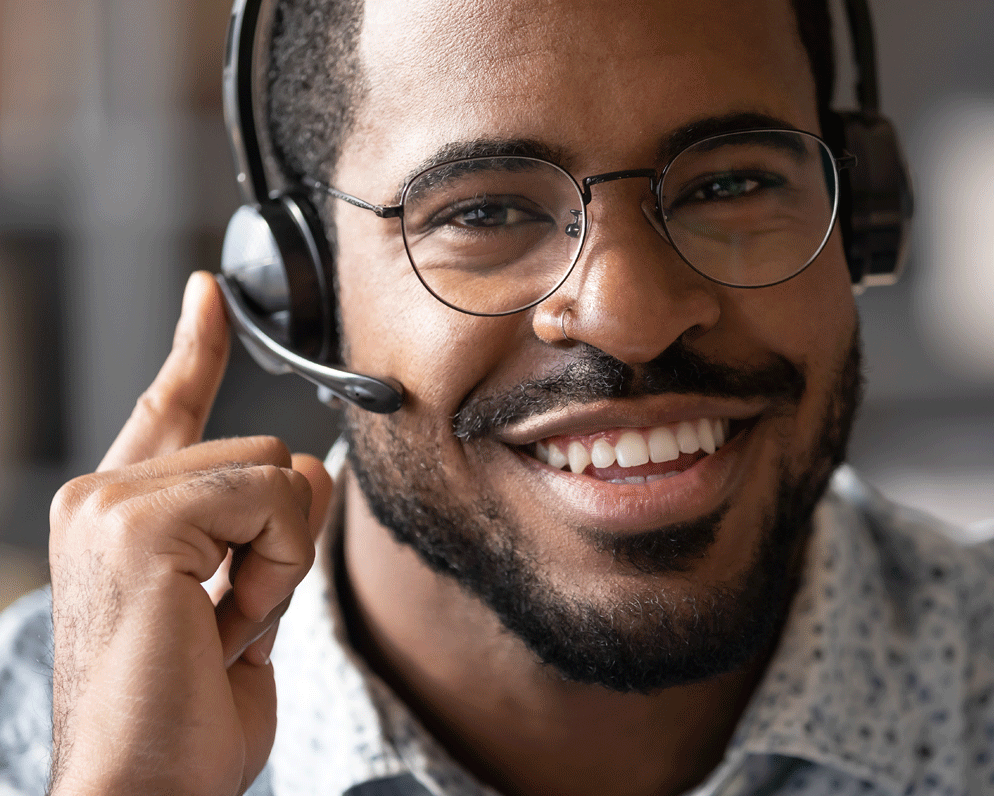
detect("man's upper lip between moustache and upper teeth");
top-left (497, 396), bottom-right (769, 456)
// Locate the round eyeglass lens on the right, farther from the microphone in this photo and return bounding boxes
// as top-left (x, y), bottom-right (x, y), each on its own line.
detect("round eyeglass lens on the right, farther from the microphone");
top-left (658, 130), bottom-right (839, 287)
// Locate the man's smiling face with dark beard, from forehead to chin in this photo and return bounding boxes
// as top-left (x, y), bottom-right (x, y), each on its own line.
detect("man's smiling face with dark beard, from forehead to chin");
top-left (334, 3), bottom-right (858, 690)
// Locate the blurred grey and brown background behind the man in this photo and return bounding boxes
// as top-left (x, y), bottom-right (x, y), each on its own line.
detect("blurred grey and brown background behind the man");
top-left (0, 0), bottom-right (994, 606)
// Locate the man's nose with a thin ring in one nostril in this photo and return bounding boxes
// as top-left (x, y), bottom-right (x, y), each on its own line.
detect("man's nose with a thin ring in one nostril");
top-left (533, 183), bottom-right (723, 365)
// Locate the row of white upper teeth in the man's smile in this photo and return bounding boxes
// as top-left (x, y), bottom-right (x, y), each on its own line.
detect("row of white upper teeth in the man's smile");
top-left (535, 418), bottom-right (728, 473)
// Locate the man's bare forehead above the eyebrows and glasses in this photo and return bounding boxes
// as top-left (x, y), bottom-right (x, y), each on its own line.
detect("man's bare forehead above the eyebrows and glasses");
top-left (343, 0), bottom-right (817, 179)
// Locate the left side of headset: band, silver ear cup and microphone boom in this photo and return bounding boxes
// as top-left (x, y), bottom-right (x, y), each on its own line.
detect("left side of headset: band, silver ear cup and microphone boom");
top-left (217, 0), bottom-right (404, 413)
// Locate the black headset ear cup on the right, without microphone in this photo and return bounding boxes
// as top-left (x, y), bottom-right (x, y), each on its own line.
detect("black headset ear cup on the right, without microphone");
top-left (835, 112), bottom-right (914, 287)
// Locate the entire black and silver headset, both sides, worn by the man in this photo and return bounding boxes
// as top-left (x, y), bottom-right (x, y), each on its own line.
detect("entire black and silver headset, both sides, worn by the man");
top-left (217, 0), bottom-right (914, 413)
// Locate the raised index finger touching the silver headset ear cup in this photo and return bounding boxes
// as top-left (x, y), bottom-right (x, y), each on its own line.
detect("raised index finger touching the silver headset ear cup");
top-left (97, 271), bottom-right (229, 470)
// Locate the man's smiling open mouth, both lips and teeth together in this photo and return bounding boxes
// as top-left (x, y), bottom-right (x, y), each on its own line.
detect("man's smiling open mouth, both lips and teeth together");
top-left (497, 396), bottom-right (775, 534)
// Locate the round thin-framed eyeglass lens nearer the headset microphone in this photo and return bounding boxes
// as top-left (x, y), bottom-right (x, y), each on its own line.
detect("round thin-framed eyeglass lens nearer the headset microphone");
top-left (403, 157), bottom-right (585, 315)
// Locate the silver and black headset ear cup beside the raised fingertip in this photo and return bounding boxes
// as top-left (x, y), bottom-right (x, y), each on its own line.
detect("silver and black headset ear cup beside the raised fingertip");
top-left (221, 195), bottom-right (334, 361)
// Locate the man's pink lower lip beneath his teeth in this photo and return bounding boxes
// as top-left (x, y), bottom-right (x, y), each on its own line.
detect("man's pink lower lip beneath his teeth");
top-left (511, 410), bottom-right (761, 535)
